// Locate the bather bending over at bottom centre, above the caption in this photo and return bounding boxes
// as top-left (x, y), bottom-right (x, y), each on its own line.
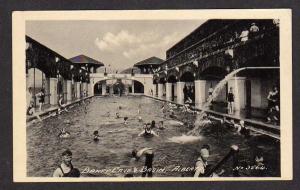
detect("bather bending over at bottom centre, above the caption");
top-left (132, 148), bottom-right (154, 177)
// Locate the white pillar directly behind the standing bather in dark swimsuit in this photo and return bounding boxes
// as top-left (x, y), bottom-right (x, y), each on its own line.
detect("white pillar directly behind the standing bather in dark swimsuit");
top-left (228, 77), bottom-right (246, 111)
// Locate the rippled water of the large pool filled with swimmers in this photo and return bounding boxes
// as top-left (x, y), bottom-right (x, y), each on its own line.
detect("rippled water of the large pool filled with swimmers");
top-left (26, 96), bottom-right (280, 177)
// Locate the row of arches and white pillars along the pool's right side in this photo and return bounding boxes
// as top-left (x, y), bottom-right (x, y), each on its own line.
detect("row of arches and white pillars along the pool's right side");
top-left (153, 67), bottom-right (279, 110)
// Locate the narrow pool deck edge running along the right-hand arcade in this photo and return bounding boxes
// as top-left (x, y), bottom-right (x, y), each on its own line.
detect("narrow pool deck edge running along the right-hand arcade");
top-left (144, 95), bottom-right (280, 140)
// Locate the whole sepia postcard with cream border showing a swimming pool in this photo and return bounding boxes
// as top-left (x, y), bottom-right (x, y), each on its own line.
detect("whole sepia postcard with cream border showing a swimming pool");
top-left (13, 9), bottom-right (292, 182)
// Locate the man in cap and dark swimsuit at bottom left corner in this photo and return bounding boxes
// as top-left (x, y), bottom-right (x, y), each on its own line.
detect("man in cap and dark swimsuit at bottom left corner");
top-left (53, 149), bottom-right (80, 177)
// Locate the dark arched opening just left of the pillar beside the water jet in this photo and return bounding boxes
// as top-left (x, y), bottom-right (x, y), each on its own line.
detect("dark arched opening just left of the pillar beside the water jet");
top-left (180, 71), bottom-right (195, 104)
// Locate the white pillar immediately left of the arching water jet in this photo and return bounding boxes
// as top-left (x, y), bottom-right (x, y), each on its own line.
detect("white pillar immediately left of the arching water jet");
top-left (195, 80), bottom-right (207, 108)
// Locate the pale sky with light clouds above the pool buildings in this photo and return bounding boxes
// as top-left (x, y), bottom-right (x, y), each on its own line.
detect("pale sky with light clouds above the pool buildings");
top-left (26, 20), bottom-right (205, 71)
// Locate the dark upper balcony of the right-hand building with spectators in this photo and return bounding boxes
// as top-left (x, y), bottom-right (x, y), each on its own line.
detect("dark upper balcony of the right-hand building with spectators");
top-left (158, 20), bottom-right (279, 72)
